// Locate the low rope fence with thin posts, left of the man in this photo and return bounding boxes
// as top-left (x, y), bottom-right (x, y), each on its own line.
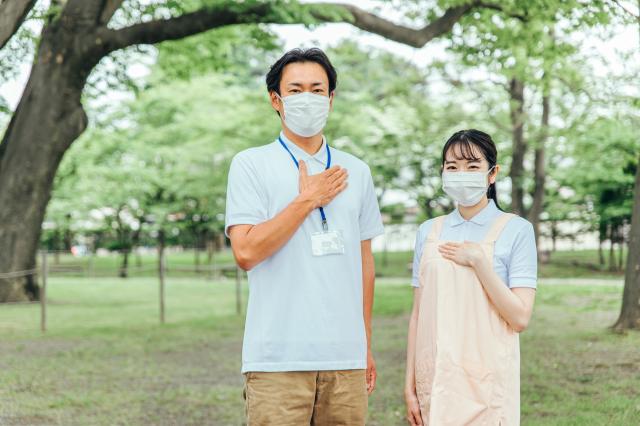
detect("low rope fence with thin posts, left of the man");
top-left (0, 251), bottom-right (244, 333)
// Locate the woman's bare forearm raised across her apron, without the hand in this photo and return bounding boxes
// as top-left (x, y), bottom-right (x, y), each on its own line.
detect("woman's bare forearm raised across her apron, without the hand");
top-left (471, 257), bottom-right (533, 332)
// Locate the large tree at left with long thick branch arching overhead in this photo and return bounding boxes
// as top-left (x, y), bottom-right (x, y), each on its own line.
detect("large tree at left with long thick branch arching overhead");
top-left (0, 0), bottom-right (516, 302)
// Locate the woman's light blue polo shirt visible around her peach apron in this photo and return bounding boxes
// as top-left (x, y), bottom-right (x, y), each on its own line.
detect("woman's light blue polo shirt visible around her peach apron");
top-left (411, 200), bottom-right (538, 288)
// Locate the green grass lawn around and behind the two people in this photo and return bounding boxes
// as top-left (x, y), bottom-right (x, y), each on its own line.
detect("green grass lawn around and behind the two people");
top-left (0, 277), bottom-right (640, 426)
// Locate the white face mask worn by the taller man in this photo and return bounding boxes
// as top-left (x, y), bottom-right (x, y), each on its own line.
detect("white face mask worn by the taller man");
top-left (276, 92), bottom-right (330, 138)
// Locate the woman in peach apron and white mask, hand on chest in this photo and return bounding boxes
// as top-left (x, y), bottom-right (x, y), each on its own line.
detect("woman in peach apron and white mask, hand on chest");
top-left (405, 129), bottom-right (537, 426)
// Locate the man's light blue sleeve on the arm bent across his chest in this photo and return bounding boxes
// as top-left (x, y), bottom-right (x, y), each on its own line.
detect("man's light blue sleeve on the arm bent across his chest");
top-left (224, 153), bottom-right (268, 237)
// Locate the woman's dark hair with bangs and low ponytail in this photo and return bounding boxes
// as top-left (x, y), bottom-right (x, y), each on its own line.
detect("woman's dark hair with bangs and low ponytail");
top-left (442, 129), bottom-right (502, 210)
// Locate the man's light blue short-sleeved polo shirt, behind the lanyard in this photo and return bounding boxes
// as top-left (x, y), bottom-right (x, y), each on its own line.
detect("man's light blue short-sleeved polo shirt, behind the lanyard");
top-left (225, 134), bottom-right (383, 373)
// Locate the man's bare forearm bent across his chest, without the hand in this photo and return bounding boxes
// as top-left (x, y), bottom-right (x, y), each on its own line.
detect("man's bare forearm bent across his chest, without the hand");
top-left (231, 195), bottom-right (314, 270)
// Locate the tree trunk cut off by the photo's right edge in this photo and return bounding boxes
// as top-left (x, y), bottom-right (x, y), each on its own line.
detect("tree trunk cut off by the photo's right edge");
top-left (613, 150), bottom-right (640, 331)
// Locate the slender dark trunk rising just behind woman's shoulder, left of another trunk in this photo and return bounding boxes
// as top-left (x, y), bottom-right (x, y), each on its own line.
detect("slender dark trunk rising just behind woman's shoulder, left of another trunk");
top-left (509, 78), bottom-right (527, 216)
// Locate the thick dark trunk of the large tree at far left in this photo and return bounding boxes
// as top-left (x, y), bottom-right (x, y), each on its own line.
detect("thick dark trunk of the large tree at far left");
top-left (0, 21), bottom-right (93, 302)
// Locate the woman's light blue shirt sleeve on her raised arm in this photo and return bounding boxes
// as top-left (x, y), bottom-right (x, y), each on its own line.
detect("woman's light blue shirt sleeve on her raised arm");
top-left (509, 222), bottom-right (538, 288)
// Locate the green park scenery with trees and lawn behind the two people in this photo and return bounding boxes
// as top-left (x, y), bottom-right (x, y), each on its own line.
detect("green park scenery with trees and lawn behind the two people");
top-left (0, 0), bottom-right (640, 426)
